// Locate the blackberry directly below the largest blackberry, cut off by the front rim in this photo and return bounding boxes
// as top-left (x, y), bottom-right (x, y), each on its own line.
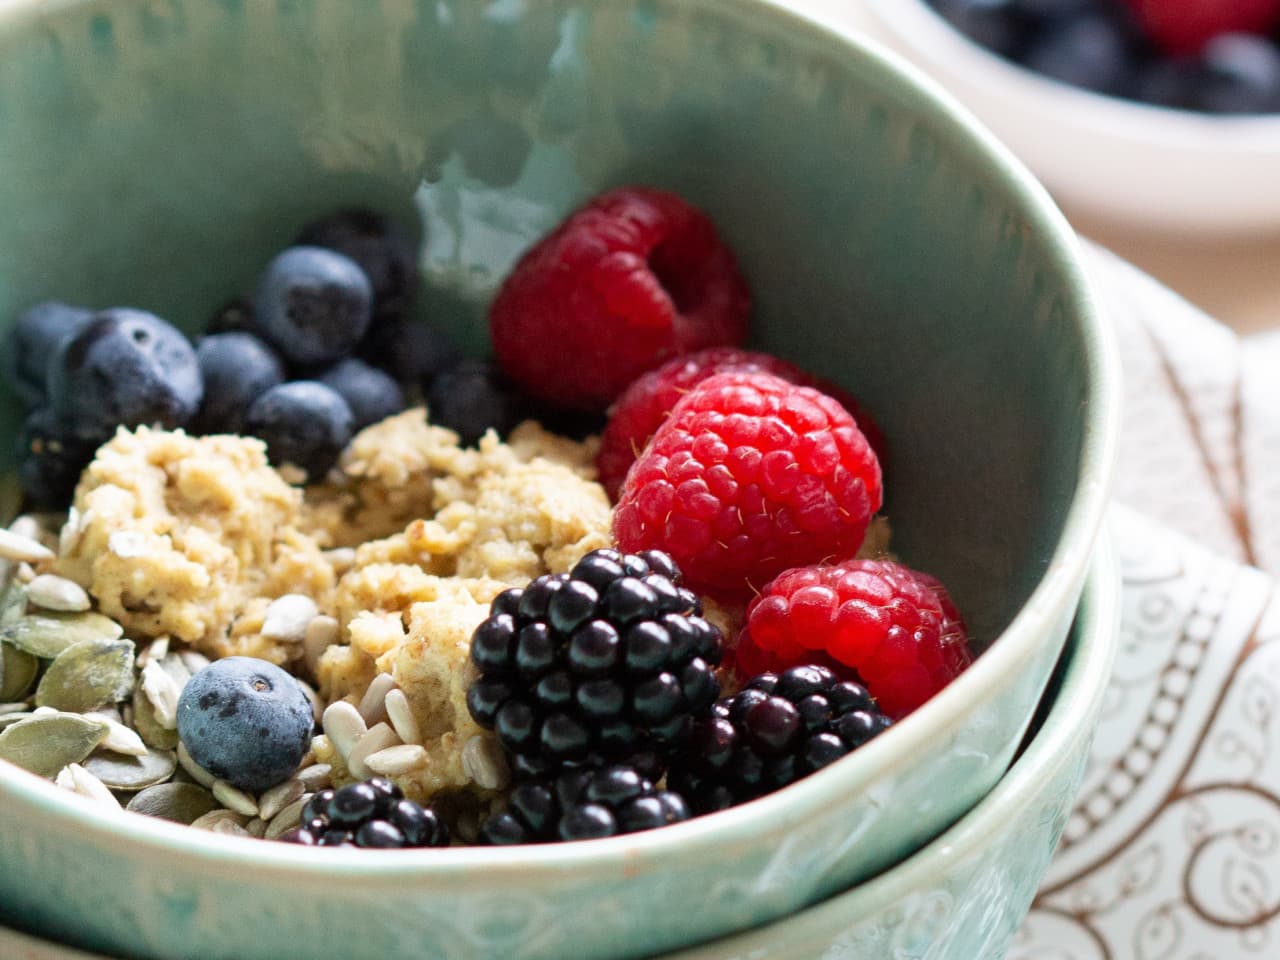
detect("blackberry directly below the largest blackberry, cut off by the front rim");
top-left (480, 764), bottom-right (690, 845)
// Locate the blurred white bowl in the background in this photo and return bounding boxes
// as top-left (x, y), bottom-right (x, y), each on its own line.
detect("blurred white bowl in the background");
top-left (863, 0), bottom-right (1280, 234)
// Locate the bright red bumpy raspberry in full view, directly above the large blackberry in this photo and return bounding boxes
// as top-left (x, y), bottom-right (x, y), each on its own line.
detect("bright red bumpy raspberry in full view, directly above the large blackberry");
top-left (613, 372), bottom-right (881, 600)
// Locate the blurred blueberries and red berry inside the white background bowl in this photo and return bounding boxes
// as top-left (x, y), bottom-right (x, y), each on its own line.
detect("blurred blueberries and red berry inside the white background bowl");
top-left (928, 0), bottom-right (1280, 114)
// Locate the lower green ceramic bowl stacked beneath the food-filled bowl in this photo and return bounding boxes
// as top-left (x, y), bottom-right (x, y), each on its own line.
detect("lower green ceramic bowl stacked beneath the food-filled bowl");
top-left (663, 547), bottom-right (1120, 960)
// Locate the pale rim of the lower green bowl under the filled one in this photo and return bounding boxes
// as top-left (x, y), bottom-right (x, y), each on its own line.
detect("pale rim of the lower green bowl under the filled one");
top-left (662, 534), bottom-right (1121, 960)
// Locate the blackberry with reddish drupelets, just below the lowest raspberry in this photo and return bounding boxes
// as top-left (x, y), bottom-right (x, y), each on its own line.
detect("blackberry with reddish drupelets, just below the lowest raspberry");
top-left (667, 664), bottom-right (891, 813)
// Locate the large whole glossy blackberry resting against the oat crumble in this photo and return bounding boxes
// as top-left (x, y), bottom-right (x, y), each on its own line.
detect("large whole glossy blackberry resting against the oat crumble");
top-left (467, 549), bottom-right (721, 777)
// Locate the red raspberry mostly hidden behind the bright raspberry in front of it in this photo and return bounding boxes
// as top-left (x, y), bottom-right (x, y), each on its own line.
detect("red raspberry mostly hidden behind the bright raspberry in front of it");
top-left (595, 347), bottom-right (884, 500)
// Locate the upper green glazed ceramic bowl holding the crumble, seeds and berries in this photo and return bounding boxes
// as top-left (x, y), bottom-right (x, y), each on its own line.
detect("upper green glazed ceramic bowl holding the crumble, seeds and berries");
top-left (0, 0), bottom-right (1119, 960)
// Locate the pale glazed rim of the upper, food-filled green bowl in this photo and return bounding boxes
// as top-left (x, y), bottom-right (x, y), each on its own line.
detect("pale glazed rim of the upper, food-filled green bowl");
top-left (0, 0), bottom-right (1120, 906)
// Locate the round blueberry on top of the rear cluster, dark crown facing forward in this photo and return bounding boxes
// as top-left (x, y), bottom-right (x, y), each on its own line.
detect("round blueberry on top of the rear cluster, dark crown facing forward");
top-left (253, 247), bottom-right (374, 364)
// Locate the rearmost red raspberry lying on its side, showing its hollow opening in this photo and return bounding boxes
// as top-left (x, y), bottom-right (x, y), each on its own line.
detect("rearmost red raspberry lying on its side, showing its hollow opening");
top-left (489, 187), bottom-right (750, 411)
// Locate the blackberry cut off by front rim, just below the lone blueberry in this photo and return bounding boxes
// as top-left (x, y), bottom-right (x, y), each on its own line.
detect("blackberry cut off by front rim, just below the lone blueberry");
top-left (282, 777), bottom-right (449, 847)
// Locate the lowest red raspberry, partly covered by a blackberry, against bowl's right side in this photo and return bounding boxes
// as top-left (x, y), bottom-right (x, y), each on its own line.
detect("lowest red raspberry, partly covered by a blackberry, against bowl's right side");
top-left (735, 559), bottom-right (973, 719)
